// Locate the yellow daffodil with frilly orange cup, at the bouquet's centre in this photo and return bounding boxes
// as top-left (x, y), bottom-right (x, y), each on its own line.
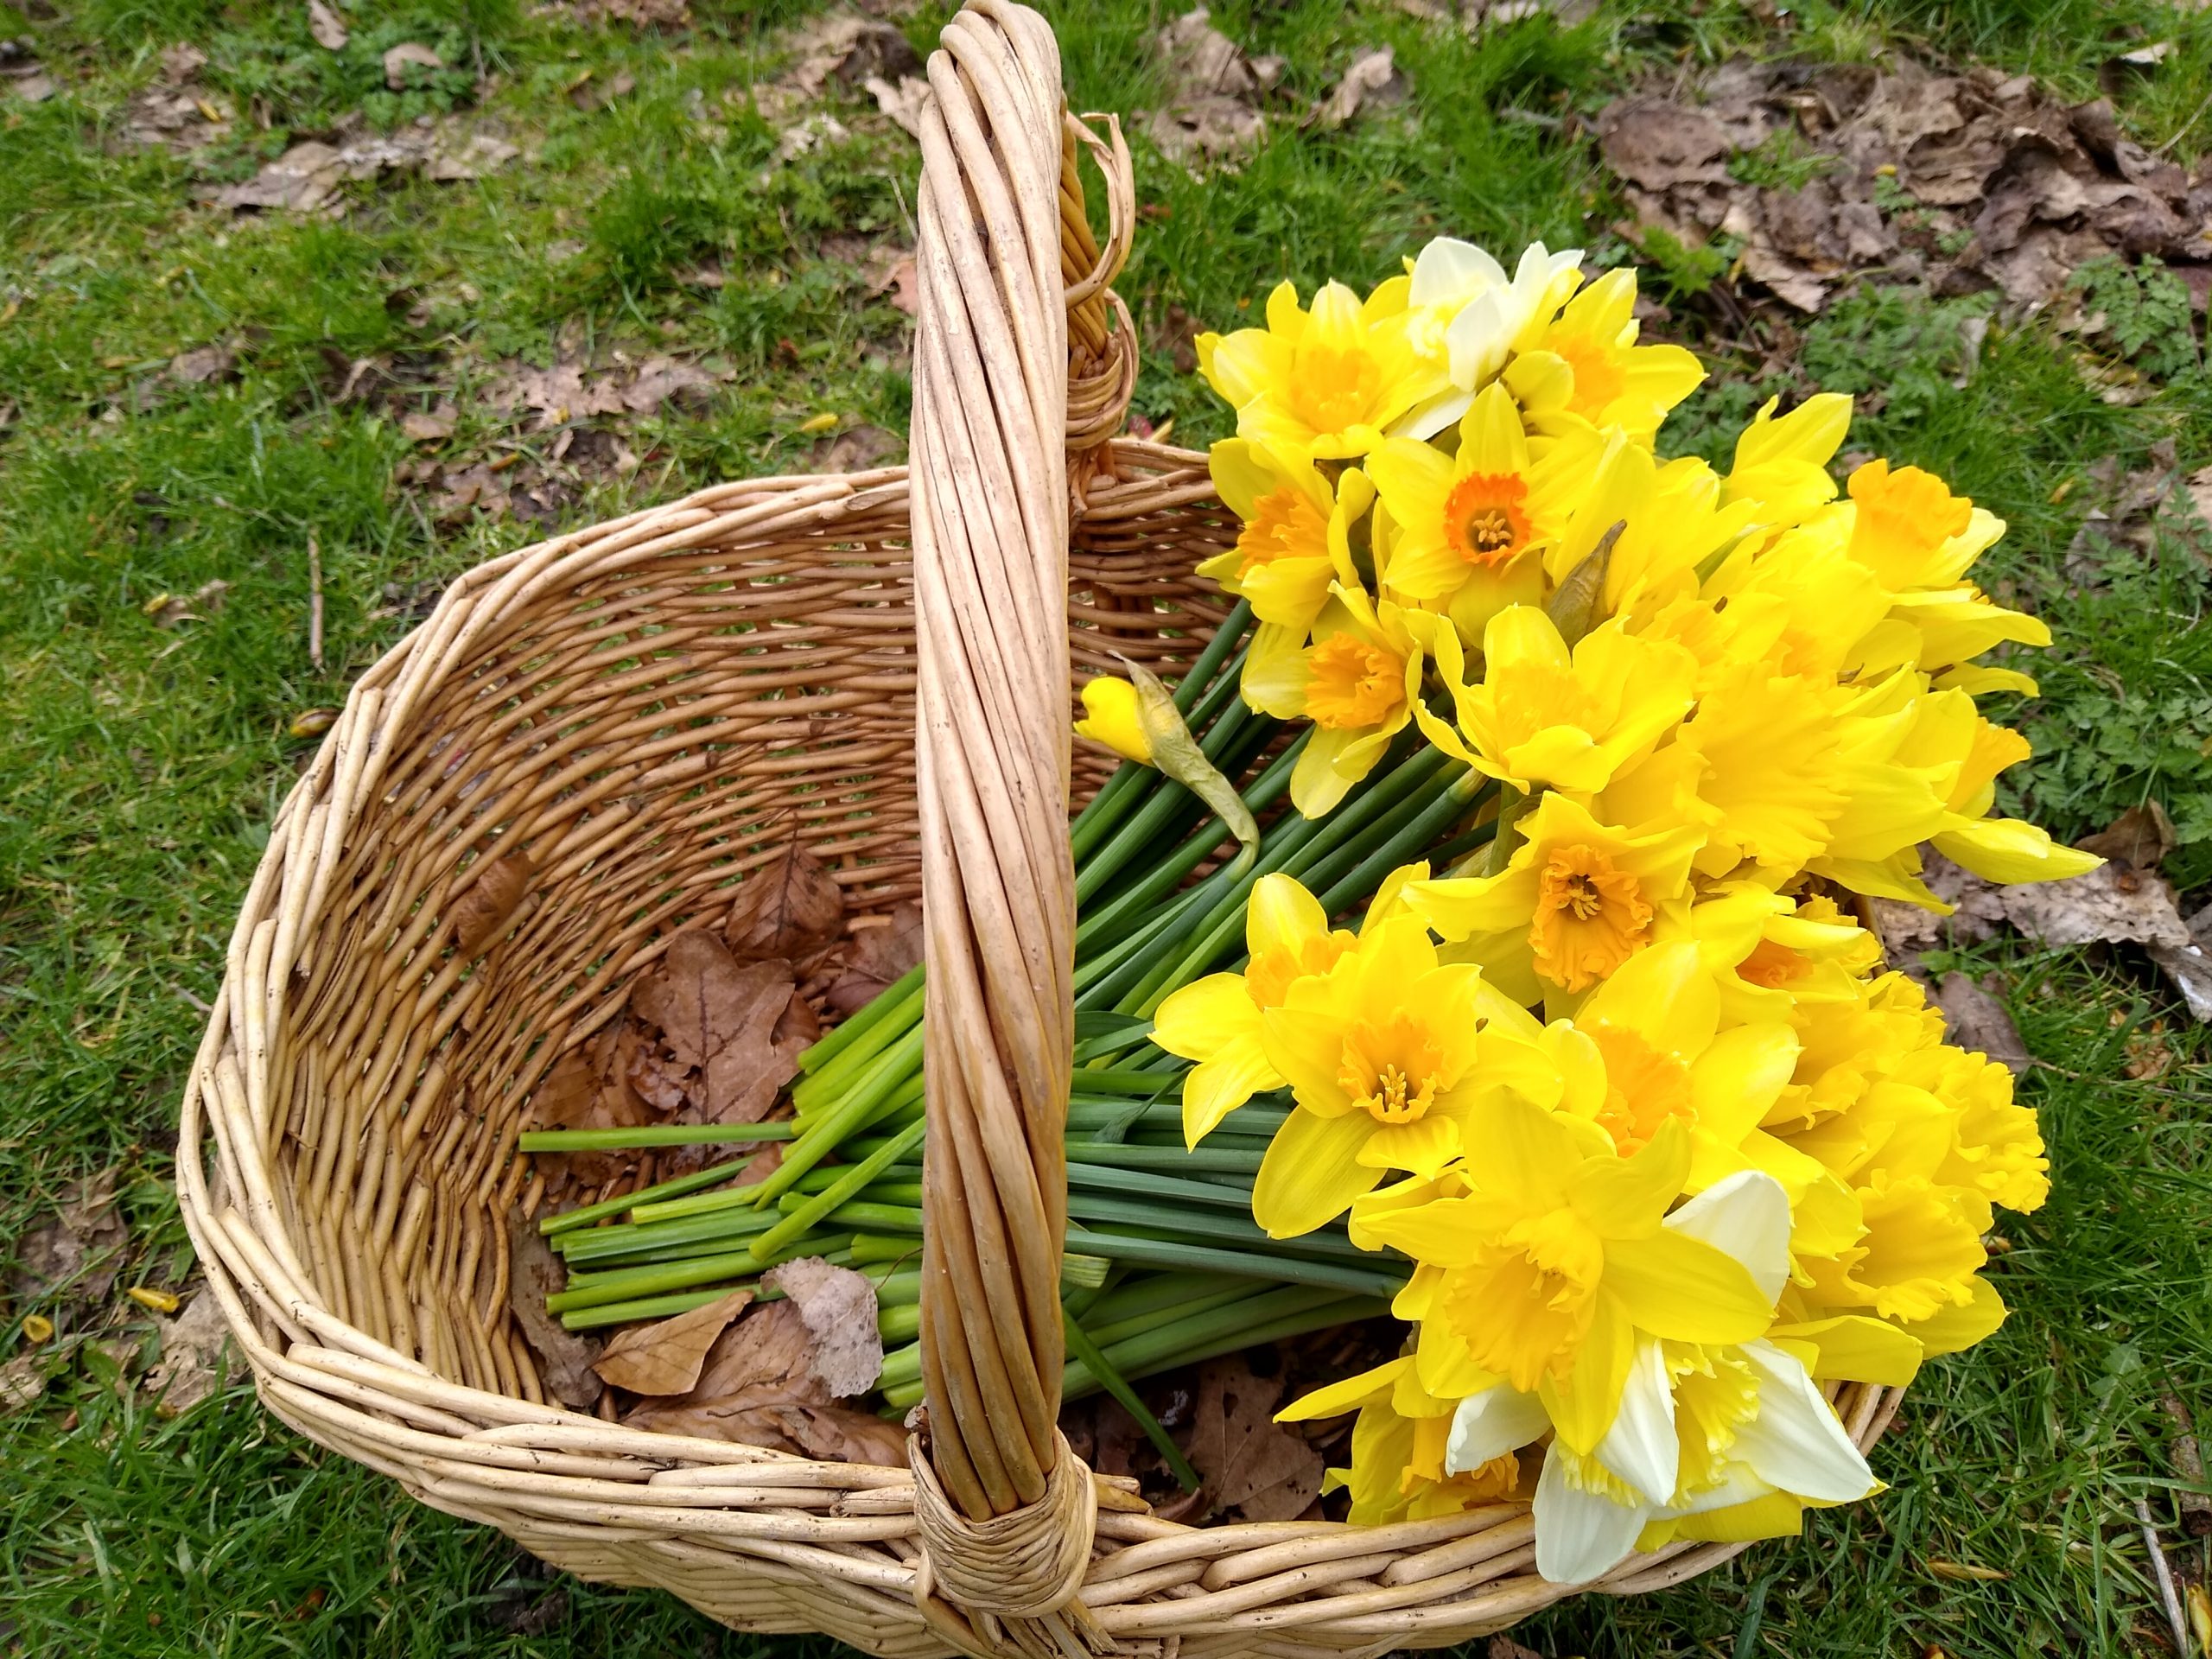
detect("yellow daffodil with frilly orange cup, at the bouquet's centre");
top-left (1407, 791), bottom-right (1703, 1002)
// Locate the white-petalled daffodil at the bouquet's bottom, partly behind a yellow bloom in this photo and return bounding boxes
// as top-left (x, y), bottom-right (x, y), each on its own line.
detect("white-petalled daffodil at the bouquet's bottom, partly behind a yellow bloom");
top-left (1445, 1170), bottom-right (1876, 1584)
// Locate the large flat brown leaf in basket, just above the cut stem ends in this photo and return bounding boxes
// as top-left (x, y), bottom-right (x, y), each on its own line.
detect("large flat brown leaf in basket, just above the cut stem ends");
top-left (631, 929), bottom-right (812, 1123)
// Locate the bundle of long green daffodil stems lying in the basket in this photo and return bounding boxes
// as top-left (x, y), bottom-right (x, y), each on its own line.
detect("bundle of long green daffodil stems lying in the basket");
top-left (522, 604), bottom-right (1496, 1465)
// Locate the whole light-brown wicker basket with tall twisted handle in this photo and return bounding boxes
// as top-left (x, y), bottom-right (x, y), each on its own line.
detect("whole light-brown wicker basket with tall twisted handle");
top-left (179, 0), bottom-right (1896, 1656)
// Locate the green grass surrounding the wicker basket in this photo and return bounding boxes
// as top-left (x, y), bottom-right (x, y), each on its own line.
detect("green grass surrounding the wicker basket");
top-left (0, 0), bottom-right (2212, 1659)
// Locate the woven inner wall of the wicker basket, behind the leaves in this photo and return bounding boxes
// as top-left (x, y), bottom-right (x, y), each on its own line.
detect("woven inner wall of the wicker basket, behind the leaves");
top-left (270, 462), bottom-right (1236, 1400)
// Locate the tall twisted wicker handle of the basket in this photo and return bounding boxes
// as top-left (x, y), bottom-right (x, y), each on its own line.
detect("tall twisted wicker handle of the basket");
top-left (912, 0), bottom-right (1135, 1650)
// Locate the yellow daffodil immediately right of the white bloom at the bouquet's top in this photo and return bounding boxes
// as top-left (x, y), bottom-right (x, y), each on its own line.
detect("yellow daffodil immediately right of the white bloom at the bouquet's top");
top-left (1504, 268), bottom-right (1706, 445)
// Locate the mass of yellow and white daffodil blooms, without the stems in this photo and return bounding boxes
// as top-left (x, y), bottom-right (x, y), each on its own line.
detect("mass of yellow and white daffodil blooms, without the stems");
top-left (1123, 241), bottom-right (2094, 1581)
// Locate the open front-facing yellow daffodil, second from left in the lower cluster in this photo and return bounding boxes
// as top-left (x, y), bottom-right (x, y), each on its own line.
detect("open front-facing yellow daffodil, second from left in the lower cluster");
top-left (1252, 913), bottom-right (1517, 1239)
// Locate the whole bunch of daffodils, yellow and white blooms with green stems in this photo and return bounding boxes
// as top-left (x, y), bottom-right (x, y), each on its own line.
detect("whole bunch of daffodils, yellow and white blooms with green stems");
top-left (522, 227), bottom-right (2094, 1584)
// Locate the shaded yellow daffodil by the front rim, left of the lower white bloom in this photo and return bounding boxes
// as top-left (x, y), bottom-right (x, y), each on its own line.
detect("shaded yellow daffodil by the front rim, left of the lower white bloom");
top-left (1276, 1356), bottom-right (1533, 1526)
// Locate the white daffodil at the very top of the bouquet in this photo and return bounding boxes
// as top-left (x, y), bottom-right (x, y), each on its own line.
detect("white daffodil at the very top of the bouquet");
top-left (1394, 237), bottom-right (1581, 438)
